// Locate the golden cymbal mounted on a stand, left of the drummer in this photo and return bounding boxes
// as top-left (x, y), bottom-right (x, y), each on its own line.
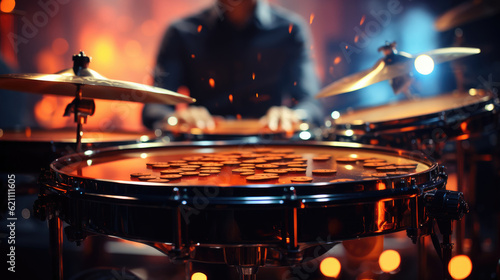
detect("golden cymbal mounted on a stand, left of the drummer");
top-left (0, 68), bottom-right (196, 105)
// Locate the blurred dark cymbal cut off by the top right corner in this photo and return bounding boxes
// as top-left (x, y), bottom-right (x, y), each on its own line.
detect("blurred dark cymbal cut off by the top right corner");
top-left (434, 0), bottom-right (500, 31)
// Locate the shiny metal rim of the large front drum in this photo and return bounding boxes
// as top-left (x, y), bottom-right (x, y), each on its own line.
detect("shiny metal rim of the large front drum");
top-left (41, 141), bottom-right (440, 207)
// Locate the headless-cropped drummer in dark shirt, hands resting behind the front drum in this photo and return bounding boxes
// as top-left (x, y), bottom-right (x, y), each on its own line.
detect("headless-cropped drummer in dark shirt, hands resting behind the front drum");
top-left (143, 0), bottom-right (323, 130)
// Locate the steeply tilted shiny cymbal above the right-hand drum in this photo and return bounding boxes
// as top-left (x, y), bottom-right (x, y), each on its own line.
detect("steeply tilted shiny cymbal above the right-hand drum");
top-left (316, 47), bottom-right (480, 98)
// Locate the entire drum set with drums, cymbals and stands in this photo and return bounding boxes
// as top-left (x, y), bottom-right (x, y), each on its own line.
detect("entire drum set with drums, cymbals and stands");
top-left (0, 44), bottom-right (500, 279)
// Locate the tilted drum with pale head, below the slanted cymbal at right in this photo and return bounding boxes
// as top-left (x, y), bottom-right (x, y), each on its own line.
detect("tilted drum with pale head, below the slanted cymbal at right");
top-left (330, 93), bottom-right (500, 150)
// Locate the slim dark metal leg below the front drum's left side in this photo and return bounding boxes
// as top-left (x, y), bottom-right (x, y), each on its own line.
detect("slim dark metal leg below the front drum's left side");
top-left (49, 214), bottom-right (63, 280)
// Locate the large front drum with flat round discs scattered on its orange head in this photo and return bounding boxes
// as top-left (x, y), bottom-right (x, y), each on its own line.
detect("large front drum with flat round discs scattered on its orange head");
top-left (38, 142), bottom-right (446, 265)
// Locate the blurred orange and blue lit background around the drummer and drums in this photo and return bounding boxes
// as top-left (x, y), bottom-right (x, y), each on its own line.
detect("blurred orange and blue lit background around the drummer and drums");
top-left (0, 0), bottom-right (500, 280)
